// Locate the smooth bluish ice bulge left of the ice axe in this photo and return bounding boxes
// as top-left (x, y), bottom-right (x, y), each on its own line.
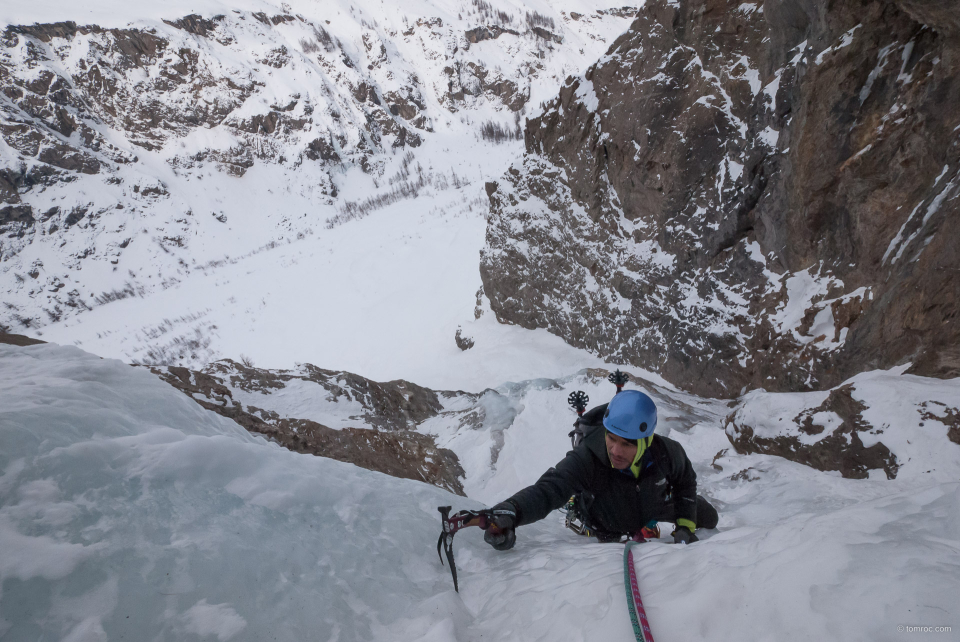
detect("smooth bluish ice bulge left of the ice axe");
top-left (0, 345), bottom-right (476, 640)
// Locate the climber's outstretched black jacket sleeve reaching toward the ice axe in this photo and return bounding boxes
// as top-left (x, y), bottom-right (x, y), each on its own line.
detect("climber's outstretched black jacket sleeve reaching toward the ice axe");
top-left (507, 444), bottom-right (593, 526)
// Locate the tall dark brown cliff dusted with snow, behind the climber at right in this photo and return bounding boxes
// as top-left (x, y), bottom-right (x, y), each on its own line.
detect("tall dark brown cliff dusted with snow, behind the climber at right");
top-left (481, 0), bottom-right (960, 397)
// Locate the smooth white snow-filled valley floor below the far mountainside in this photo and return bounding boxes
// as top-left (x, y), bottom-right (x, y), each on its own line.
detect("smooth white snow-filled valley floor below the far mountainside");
top-left (37, 134), bottom-right (616, 391)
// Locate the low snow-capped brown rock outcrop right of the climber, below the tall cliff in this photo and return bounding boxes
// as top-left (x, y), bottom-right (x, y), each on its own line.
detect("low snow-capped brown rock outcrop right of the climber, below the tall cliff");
top-left (718, 368), bottom-right (960, 479)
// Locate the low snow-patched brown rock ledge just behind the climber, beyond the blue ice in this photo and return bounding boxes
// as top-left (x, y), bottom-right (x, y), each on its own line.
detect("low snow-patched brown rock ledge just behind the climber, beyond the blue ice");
top-left (146, 359), bottom-right (722, 494)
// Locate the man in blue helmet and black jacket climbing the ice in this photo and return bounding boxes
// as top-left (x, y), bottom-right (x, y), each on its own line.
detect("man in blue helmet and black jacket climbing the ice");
top-left (483, 390), bottom-right (718, 551)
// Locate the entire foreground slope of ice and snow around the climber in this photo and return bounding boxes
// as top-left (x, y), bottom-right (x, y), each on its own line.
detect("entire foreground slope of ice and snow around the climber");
top-left (0, 338), bottom-right (960, 642)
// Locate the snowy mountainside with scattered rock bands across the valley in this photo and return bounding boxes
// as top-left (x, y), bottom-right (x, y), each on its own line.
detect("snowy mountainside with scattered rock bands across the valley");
top-left (0, 0), bottom-right (635, 362)
